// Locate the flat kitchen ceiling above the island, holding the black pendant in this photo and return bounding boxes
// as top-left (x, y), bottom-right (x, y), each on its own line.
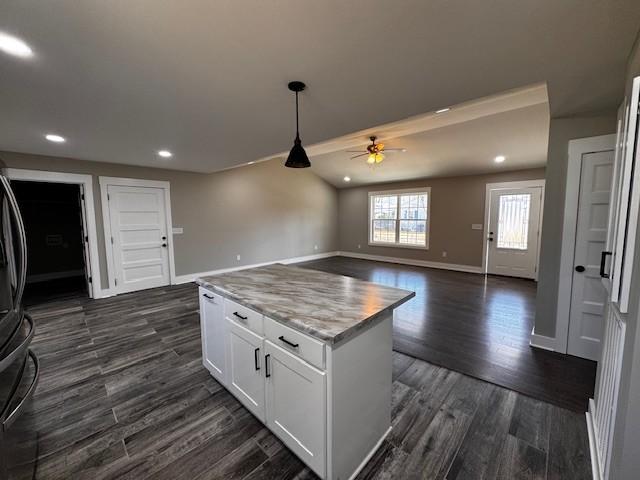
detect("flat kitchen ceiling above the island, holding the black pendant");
top-left (0, 0), bottom-right (640, 172)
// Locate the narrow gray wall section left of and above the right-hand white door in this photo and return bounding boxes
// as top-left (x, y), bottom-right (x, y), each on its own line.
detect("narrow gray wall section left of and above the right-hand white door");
top-left (535, 112), bottom-right (616, 337)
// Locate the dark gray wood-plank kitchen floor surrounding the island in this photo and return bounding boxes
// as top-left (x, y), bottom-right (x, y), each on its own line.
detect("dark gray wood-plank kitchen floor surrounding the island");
top-left (22, 284), bottom-right (590, 480)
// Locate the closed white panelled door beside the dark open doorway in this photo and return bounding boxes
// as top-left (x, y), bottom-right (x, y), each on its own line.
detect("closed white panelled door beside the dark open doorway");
top-left (107, 185), bottom-right (170, 293)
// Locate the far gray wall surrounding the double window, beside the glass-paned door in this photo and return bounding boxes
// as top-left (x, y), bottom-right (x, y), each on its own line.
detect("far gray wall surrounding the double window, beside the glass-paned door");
top-left (338, 168), bottom-right (545, 266)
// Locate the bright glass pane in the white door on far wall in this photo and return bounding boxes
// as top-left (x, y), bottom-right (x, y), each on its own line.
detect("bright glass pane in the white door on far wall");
top-left (497, 193), bottom-right (531, 250)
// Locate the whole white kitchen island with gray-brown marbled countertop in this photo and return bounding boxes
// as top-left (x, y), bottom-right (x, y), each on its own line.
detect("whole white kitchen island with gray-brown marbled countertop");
top-left (197, 264), bottom-right (415, 480)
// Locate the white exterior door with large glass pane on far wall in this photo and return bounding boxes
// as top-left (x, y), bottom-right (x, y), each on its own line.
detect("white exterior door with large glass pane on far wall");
top-left (487, 187), bottom-right (542, 278)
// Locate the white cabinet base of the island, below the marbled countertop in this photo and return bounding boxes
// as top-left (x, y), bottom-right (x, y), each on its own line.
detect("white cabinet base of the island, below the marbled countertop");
top-left (200, 288), bottom-right (393, 480)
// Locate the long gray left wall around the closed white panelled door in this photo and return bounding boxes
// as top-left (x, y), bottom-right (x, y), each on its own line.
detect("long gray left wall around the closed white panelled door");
top-left (0, 152), bottom-right (338, 288)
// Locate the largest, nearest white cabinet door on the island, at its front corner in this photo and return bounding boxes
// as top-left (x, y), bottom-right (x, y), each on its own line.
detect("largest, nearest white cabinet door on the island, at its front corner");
top-left (265, 340), bottom-right (327, 477)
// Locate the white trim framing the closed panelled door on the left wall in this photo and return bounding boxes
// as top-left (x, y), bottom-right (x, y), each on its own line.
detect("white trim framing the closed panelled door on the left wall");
top-left (98, 176), bottom-right (176, 296)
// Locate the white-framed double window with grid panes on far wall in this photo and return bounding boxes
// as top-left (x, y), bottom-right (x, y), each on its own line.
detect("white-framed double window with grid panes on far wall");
top-left (369, 188), bottom-right (431, 248)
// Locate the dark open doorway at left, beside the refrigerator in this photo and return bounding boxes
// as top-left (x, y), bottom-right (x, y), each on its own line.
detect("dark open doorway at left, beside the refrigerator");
top-left (11, 180), bottom-right (91, 305)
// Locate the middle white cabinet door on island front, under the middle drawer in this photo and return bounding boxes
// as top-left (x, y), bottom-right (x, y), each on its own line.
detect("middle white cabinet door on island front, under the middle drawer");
top-left (227, 319), bottom-right (265, 422)
